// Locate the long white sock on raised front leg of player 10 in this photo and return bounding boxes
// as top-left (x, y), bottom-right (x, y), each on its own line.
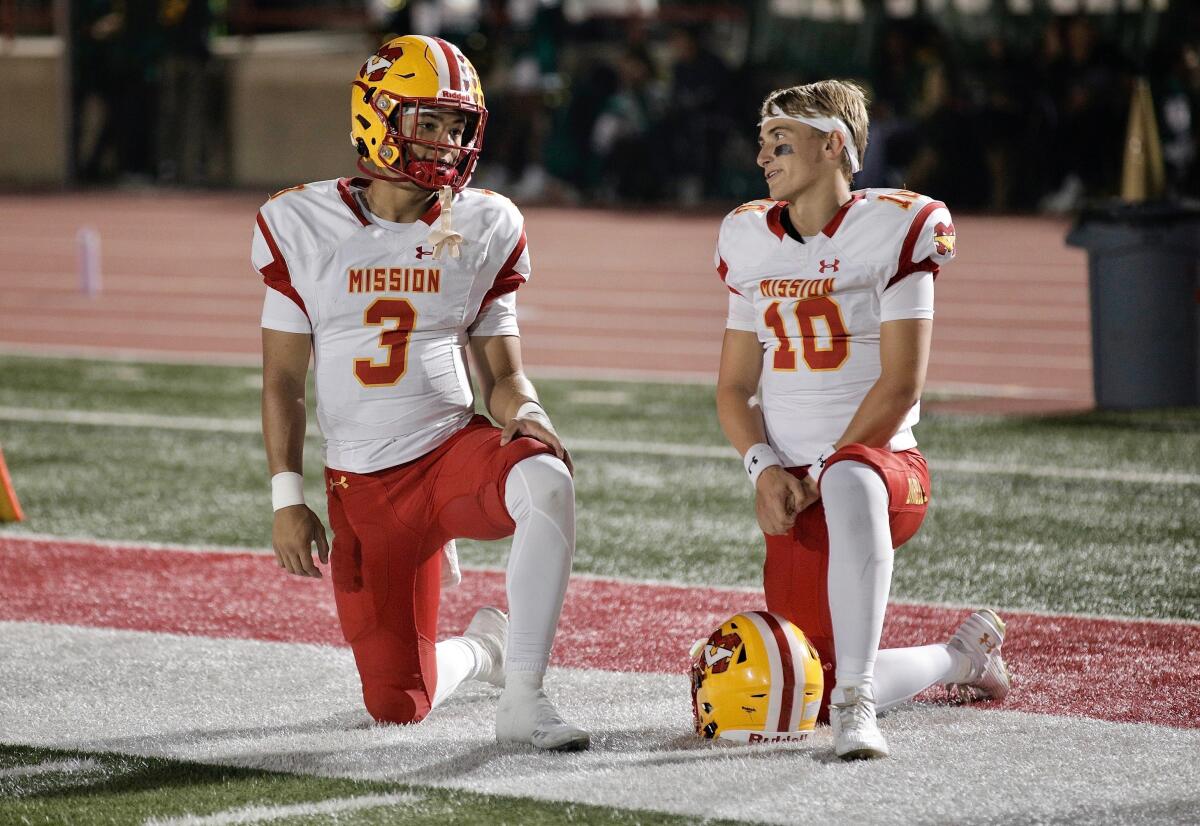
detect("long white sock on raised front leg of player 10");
top-left (821, 461), bottom-right (893, 696)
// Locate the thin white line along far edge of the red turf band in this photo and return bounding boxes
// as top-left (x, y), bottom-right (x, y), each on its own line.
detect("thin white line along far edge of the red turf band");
top-left (9, 527), bottom-right (1200, 626)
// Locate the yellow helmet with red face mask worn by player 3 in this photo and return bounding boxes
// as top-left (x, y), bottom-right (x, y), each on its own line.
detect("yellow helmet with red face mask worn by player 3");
top-left (350, 35), bottom-right (487, 192)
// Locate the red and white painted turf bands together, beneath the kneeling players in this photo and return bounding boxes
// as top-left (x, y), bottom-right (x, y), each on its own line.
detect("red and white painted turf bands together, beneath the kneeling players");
top-left (0, 537), bottom-right (1200, 822)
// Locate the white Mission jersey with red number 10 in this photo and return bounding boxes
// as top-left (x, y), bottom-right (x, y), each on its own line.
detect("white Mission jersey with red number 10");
top-left (715, 190), bottom-right (954, 466)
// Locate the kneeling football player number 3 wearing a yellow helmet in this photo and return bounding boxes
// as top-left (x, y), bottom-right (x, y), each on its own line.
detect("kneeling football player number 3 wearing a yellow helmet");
top-left (252, 36), bottom-right (589, 750)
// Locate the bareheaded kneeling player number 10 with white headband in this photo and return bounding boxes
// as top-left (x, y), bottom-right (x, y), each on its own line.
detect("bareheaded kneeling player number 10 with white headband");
top-left (715, 80), bottom-right (1009, 759)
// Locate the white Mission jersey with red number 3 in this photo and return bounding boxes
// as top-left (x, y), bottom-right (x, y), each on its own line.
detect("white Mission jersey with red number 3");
top-left (251, 179), bottom-right (529, 473)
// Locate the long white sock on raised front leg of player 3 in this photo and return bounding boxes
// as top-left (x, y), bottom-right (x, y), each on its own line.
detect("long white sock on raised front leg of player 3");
top-left (504, 454), bottom-right (575, 680)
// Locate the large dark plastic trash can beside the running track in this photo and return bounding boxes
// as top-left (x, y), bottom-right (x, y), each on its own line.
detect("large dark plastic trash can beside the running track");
top-left (1067, 203), bottom-right (1200, 409)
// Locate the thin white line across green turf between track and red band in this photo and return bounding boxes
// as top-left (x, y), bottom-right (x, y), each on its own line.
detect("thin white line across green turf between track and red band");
top-left (0, 407), bottom-right (1200, 486)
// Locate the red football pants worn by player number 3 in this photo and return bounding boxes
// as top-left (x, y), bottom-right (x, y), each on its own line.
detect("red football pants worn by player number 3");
top-left (325, 415), bottom-right (553, 723)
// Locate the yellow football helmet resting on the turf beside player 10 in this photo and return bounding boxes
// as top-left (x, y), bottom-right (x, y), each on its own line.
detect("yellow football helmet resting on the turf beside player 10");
top-left (691, 611), bottom-right (824, 743)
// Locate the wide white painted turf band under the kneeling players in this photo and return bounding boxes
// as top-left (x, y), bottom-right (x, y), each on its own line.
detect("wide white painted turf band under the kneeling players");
top-left (7, 622), bottom-right (1200, 824)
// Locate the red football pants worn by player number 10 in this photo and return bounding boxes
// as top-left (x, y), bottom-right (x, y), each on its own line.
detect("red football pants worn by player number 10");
top-left (762, 444), bottom-right (930, 722)
